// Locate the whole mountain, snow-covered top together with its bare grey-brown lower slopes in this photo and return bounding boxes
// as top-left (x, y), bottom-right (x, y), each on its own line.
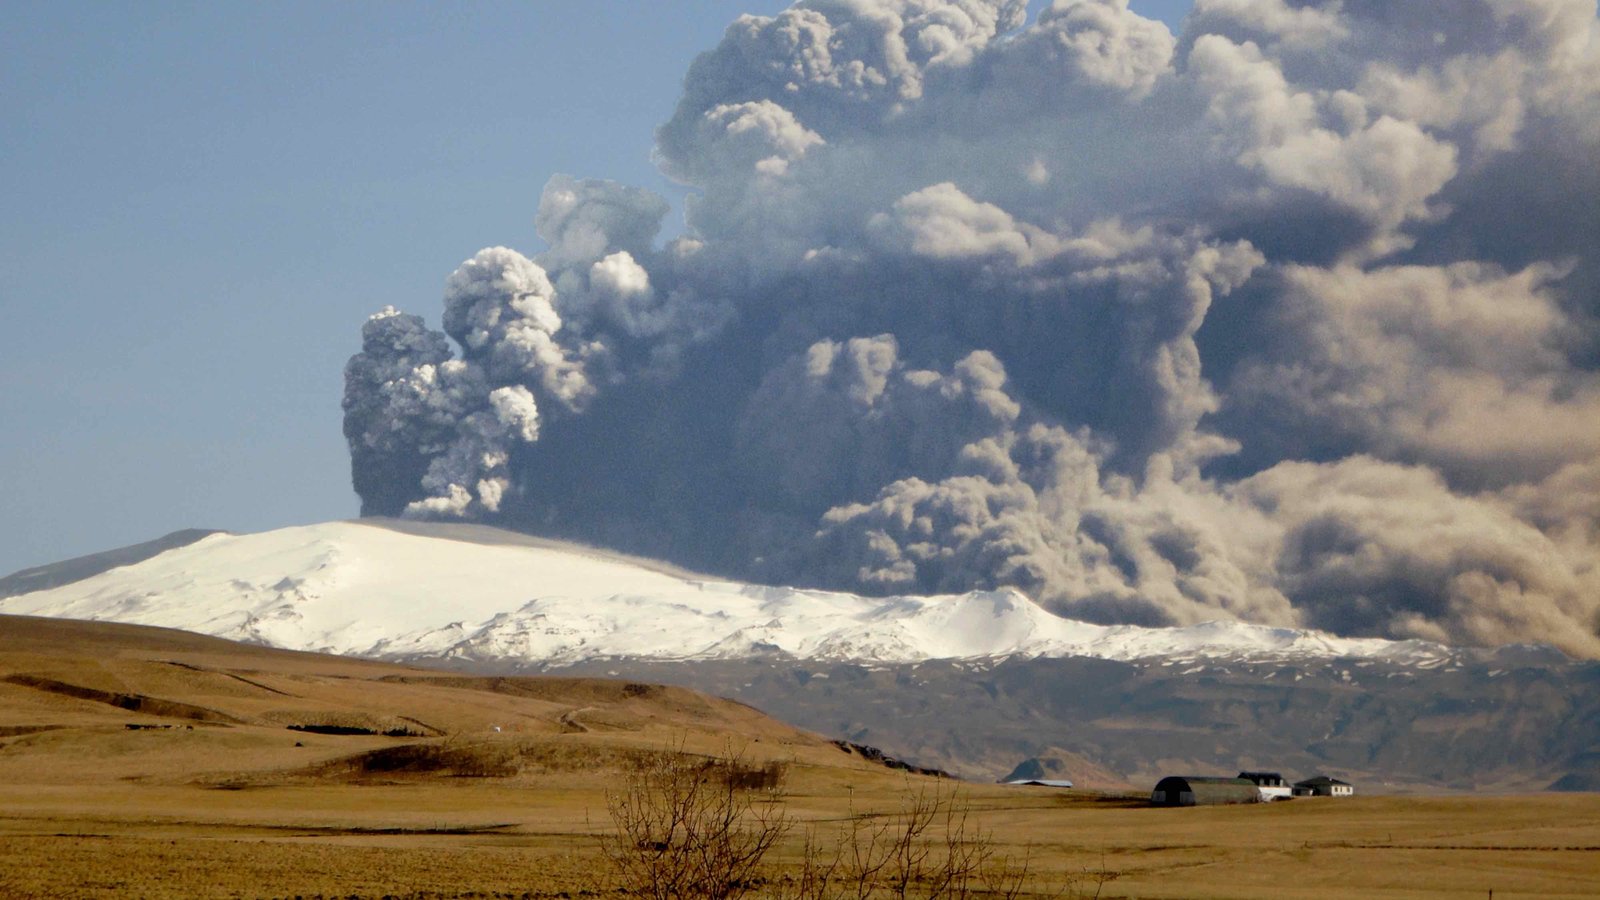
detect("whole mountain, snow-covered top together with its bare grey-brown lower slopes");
top-left (0, 520), bottom-right (1600, 791)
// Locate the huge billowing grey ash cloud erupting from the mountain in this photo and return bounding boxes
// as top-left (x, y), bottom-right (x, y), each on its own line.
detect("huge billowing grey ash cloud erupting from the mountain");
top-left (346, 0), bottom-right (1600, 657)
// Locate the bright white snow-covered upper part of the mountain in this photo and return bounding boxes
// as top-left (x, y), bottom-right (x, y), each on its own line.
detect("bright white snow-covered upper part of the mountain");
top-left (0, 522), bottom-right (1451, 665)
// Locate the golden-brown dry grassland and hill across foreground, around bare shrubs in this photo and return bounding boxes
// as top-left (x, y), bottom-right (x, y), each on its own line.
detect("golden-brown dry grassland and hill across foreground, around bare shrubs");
top-left (0, 617), bottom-right (1600, 900)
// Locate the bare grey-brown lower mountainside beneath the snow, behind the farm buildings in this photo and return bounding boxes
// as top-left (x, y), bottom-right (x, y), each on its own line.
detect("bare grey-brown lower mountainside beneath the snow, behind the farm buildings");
top-left (547, 650), bottom-right (1600, 793)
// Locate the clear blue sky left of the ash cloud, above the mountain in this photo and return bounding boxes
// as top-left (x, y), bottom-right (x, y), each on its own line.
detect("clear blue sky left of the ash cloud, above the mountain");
top-left (0, 0), bottom-right (1189, 573)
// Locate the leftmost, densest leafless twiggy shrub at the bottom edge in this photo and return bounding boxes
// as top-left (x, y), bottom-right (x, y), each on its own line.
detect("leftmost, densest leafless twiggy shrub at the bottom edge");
top-left (603, 748), bottom-right (790, 900)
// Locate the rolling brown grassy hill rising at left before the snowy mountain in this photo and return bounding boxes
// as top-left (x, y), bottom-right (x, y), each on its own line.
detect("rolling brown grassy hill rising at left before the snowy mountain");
top-left (0, 617), bottom-right (896, 785)
